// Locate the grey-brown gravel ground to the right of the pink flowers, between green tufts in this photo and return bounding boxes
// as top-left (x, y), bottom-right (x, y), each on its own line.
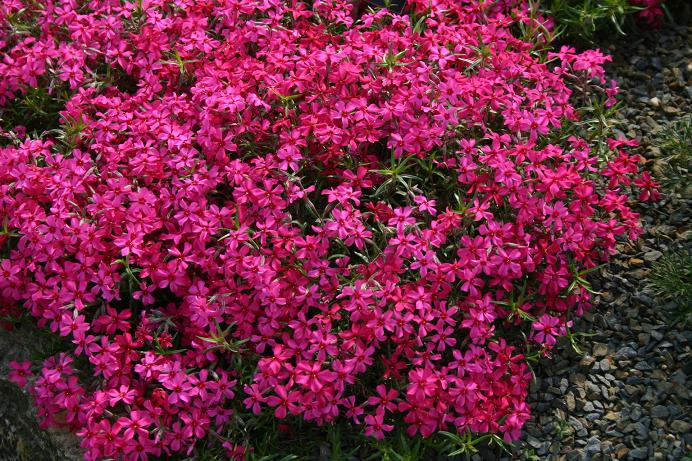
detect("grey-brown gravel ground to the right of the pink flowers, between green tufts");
top-left (516, 27), bottom-right (692, 461)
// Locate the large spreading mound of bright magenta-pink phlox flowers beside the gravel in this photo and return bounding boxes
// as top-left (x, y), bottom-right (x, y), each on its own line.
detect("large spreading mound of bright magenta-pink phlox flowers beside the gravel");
top-left (0, 0), bottom-right (658, 460)
